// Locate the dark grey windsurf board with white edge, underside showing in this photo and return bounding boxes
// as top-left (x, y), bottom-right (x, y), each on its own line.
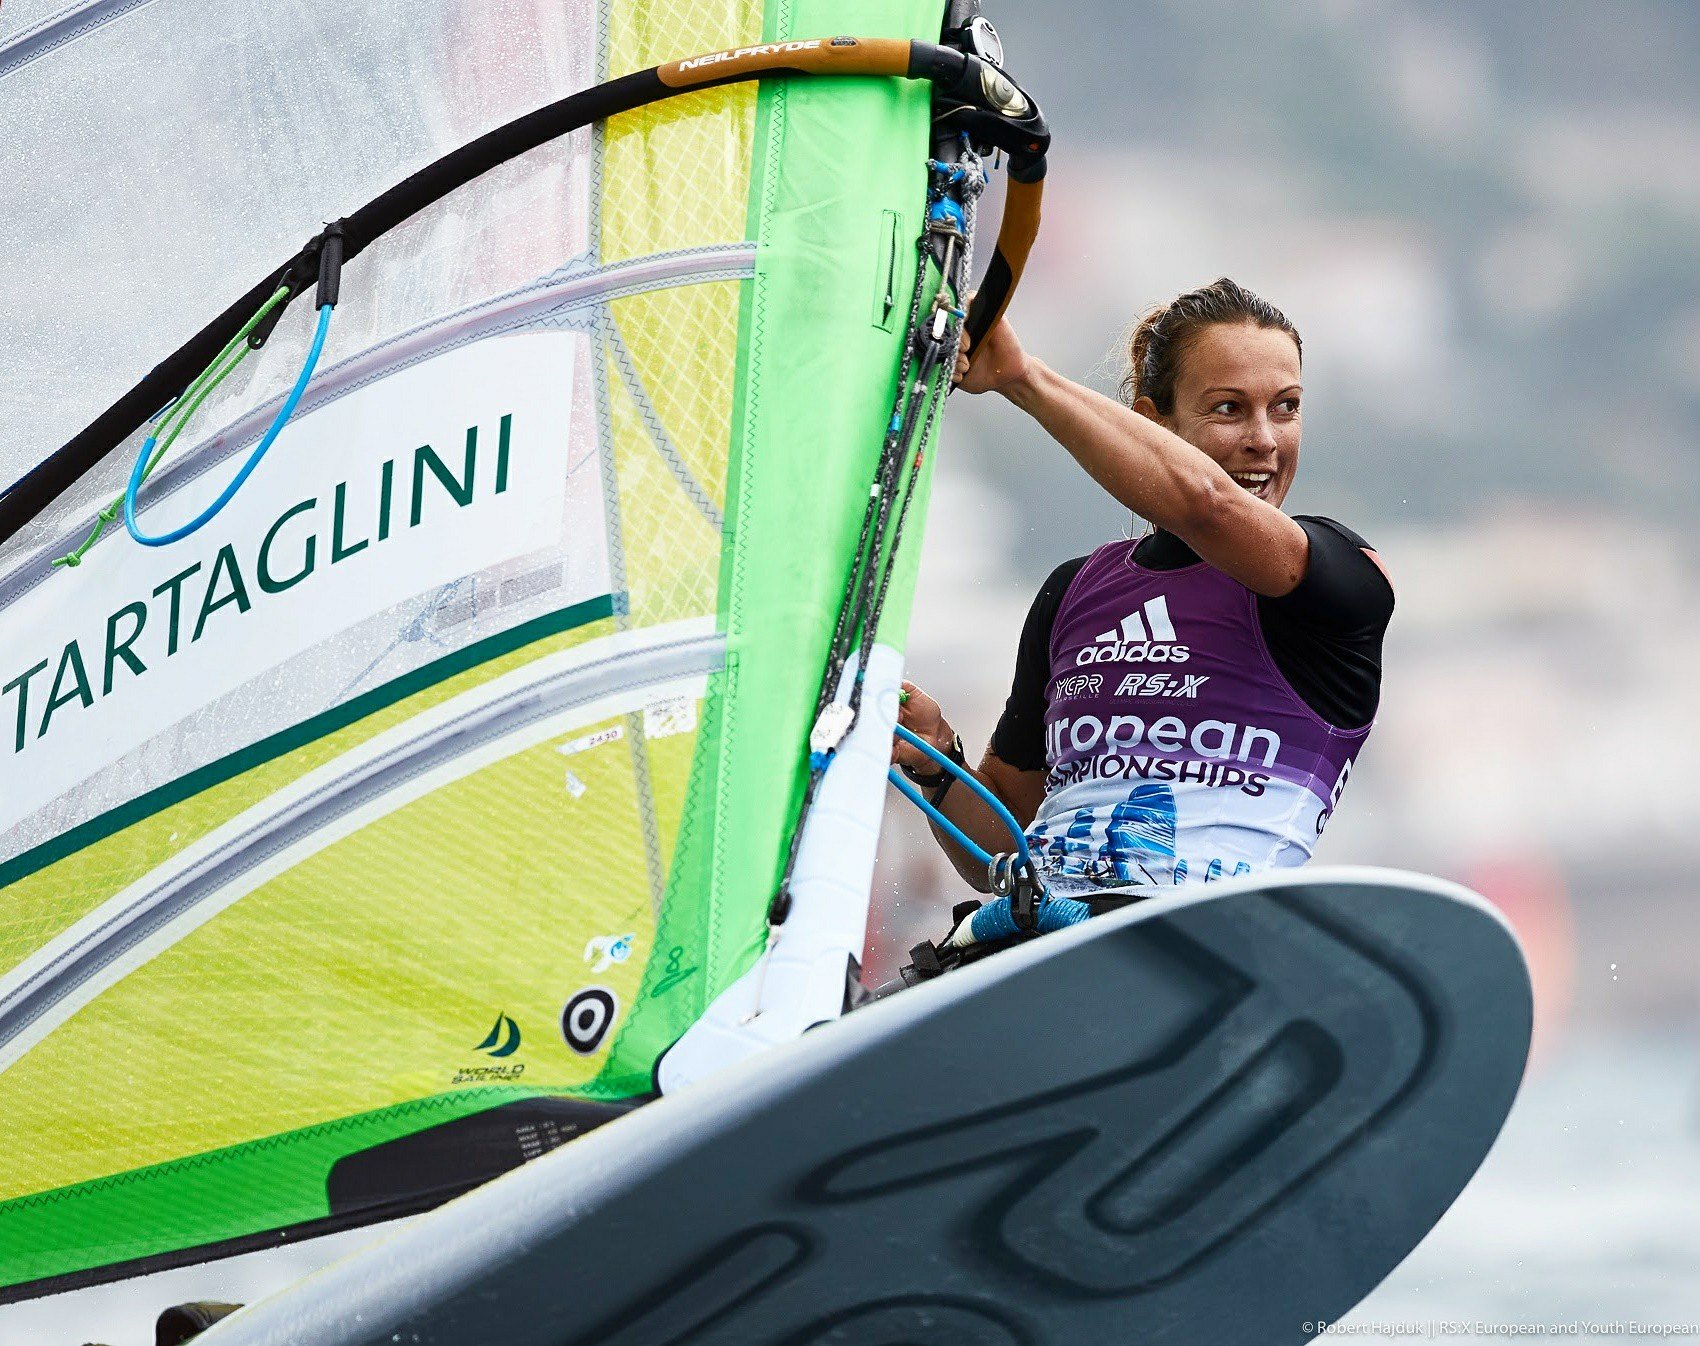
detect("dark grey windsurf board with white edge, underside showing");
top-left (204, 868), bottom-right (1532, 1346)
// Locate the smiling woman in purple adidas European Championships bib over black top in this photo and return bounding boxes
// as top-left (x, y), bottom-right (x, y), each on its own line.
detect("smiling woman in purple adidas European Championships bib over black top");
top-left (893, 279), bottom-right (1394, 894)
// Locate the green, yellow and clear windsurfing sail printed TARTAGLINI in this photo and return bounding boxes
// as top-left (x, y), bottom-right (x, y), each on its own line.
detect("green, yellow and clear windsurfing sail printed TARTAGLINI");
top-left (0, 0), bottom-right (940, 1297)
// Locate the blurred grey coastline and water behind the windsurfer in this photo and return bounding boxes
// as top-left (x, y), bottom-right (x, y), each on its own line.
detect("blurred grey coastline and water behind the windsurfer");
top-left (0, 0), bottom-right (1700, 1346)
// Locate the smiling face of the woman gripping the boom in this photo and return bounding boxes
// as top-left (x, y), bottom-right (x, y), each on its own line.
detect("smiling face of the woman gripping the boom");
top-left (1134, 323), bottom-right (1304, 506)
